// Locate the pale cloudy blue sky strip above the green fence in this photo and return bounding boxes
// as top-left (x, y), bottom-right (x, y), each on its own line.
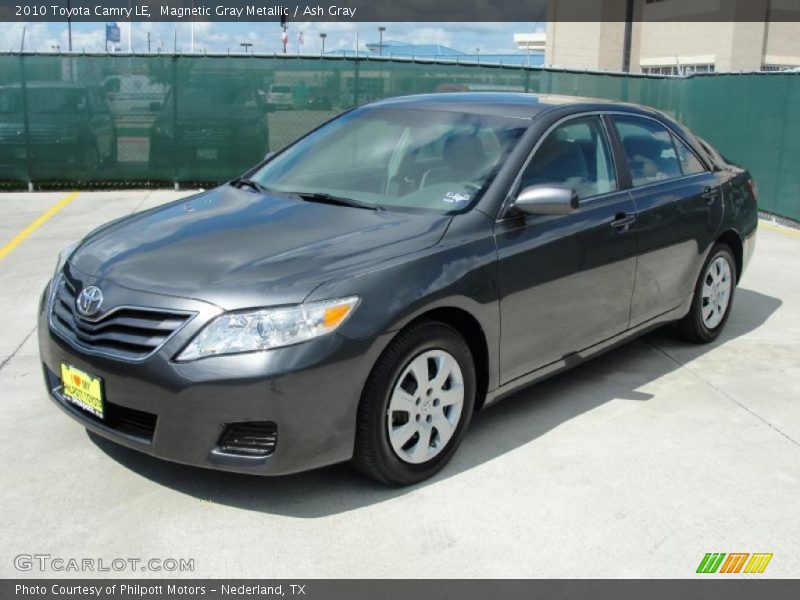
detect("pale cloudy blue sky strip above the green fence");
top-left (0, 22), bottom-right (543, 54)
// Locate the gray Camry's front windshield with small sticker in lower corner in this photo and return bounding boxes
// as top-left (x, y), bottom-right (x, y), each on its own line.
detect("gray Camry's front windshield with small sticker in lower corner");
top-left (251, 108), bottom-right (528, 213)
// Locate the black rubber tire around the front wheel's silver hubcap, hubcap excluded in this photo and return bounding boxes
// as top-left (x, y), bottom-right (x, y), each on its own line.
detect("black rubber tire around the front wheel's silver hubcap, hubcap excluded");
top-left (353, 321), bottom-right (476, 486)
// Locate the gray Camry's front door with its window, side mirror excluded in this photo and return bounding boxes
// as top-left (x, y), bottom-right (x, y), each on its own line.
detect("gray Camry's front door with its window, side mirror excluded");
top-left (495, 115), bottom-right (636, 383)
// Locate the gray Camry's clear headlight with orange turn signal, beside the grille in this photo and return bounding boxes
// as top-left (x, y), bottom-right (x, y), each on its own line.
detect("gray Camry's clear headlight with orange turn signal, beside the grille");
top-left (178, 296), bottom-right (358, 361)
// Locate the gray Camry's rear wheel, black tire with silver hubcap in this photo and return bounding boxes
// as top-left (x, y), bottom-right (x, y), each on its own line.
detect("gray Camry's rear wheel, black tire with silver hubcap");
top-left (678, 244), bottom-right (736, 344)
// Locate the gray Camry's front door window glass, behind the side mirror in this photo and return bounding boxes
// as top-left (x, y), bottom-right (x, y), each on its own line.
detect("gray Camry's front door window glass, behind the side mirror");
top-left (520, 116), bottom-right (617, 200)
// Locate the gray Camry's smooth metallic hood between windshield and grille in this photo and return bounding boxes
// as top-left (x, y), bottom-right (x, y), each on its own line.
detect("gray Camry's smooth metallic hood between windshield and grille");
top-left (70, 185), bottom-right (452, 310)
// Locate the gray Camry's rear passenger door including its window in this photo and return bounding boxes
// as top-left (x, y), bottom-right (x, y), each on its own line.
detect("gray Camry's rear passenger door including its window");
top-left (612, 115), bottom-right (722, 327)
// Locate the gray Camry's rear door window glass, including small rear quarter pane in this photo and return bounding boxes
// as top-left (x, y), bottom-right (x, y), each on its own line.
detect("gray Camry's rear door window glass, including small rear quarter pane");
top-left (614, 117), bottom-right (706, 187)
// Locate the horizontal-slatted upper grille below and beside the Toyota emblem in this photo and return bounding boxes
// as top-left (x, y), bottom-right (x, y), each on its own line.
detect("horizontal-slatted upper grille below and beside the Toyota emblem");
top-left (50, 275), bottom-right (191, 360)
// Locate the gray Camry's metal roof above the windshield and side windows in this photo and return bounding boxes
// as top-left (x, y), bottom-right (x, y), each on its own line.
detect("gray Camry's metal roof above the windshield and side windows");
top-left (368, 92), bottom-right (655, 119)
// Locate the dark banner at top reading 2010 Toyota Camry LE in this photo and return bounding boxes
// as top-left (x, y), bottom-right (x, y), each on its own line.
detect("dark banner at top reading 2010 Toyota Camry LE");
top-left (0, 0), bottom-right (800, 22)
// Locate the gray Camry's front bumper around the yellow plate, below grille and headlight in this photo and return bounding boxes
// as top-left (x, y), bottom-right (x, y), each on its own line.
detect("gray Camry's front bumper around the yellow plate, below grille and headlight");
top-left (39, 278), bottom-right (389, 475)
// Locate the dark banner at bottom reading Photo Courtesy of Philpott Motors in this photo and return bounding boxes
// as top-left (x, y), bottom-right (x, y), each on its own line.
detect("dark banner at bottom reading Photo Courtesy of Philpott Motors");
top-left (0, 575), bottom-right (800, 600)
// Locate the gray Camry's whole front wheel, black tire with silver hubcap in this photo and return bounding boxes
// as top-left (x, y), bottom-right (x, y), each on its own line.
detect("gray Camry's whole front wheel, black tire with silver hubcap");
top-left (353, 322), bottom-right (475, 485)
